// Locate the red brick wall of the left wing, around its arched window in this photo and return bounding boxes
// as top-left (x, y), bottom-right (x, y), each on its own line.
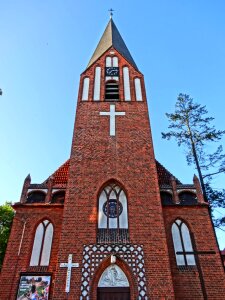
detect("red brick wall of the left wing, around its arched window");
top-left (0, 204), bottom-right (63, 300)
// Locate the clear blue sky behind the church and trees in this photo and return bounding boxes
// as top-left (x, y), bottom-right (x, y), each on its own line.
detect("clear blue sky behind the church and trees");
top-left (0, 0), bottom-right (225, 248)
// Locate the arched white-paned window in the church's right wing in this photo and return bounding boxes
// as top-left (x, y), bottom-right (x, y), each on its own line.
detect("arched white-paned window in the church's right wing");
top-left (172, 219), bottom-right (196, 266)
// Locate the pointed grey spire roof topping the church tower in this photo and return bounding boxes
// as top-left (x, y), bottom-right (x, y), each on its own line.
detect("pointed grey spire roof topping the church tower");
top-left (87, 19), bottom-right (138, 70)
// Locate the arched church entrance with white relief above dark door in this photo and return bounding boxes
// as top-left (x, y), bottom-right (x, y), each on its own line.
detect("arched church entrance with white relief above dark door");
top-left (97, 264), bottom-right (130, 300)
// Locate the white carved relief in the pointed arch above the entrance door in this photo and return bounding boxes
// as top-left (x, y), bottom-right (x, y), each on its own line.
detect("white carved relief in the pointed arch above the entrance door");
top-left (98, 264), bottom-right (129, 287)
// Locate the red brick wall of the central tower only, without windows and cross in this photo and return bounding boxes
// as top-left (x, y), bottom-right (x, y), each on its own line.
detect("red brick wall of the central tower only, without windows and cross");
top-left (51, 48), bottom-right (174, 300)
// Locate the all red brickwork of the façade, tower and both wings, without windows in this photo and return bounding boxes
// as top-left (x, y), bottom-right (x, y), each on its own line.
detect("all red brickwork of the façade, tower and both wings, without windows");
top-left (0, 45), bottom-right (225, 300)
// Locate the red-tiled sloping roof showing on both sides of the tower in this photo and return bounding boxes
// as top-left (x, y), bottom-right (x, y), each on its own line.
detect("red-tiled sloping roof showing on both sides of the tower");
top-left (44, 159), bottom-right (181, 186)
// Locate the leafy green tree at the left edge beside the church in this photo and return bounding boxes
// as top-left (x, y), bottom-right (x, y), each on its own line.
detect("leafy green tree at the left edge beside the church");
top-left (0, 202), bottom-right (14, 269)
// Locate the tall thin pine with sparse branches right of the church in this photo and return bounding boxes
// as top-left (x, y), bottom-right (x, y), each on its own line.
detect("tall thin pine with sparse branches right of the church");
top-left (162, 94), bottom-right (225, 226)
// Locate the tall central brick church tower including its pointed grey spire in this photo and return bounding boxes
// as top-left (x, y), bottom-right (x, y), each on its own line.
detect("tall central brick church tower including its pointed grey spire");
top-left (54, 19), bottom-right (174, 299)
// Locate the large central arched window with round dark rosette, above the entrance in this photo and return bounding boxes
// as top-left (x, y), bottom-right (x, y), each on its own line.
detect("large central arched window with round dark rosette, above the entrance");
top-left (98, 183), bottom-right (129, 242)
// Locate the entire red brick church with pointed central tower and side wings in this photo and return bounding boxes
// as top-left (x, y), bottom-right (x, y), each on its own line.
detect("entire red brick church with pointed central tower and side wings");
top-left (0, 18), bottom-right (225, 300)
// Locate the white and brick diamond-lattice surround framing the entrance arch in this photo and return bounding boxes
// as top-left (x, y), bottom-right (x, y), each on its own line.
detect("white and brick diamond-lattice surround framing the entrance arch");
top-left (80, 244), bottom-right (148, 300)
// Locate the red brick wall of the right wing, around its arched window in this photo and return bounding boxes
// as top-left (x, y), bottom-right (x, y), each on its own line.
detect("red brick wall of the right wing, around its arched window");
top-left (163, 205), bottom-right (225, 300)
